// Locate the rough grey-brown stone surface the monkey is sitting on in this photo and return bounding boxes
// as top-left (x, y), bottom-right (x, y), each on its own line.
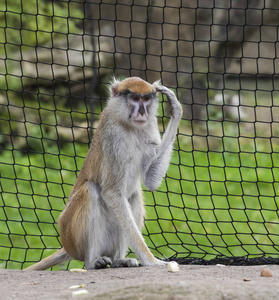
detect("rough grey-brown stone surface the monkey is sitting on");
top-left (0, 265), bottom-right (279, 300)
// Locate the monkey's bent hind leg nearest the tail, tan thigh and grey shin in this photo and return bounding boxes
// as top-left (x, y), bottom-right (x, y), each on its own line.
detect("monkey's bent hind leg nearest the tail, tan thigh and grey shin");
top-left (59, 181), bottom-right (112, 269)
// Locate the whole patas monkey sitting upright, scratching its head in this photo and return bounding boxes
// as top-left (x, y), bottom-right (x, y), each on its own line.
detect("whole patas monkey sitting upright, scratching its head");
top-left (26, 77), bottom-right (182, 270)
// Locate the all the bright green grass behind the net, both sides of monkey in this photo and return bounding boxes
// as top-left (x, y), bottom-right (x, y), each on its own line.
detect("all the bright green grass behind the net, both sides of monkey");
top-left (0, 129), bottom-right (279, 268)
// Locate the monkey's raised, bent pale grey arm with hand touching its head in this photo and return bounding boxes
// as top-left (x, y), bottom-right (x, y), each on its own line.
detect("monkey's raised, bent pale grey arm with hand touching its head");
top-left (143, 85), bottom-right (182, 191)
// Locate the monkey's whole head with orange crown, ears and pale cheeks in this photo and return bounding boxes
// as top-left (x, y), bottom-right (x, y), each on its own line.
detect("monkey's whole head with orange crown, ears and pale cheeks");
top-left (111, 77), bottom-right (158, 126)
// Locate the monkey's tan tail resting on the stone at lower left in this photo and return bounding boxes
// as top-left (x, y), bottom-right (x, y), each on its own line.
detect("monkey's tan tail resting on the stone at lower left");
top-left (24, 248), bottom-right (71, 271)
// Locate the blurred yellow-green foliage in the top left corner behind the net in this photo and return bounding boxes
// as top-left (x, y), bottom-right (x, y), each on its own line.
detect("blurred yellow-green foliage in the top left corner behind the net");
top-left (0, 0), bottom-right (83, 55)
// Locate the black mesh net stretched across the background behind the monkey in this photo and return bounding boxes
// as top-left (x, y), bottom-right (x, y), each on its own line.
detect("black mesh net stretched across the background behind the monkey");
top-left (0, 0), bottom-right (279, 269)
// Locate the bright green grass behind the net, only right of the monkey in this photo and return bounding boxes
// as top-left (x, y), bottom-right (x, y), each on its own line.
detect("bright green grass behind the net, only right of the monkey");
top-left (144, 141), bottom-right (279, 259)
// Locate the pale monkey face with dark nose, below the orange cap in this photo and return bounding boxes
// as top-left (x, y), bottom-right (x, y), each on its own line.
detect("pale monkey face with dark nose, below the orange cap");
top-left (127, 93), bottom-right (156, 126)
